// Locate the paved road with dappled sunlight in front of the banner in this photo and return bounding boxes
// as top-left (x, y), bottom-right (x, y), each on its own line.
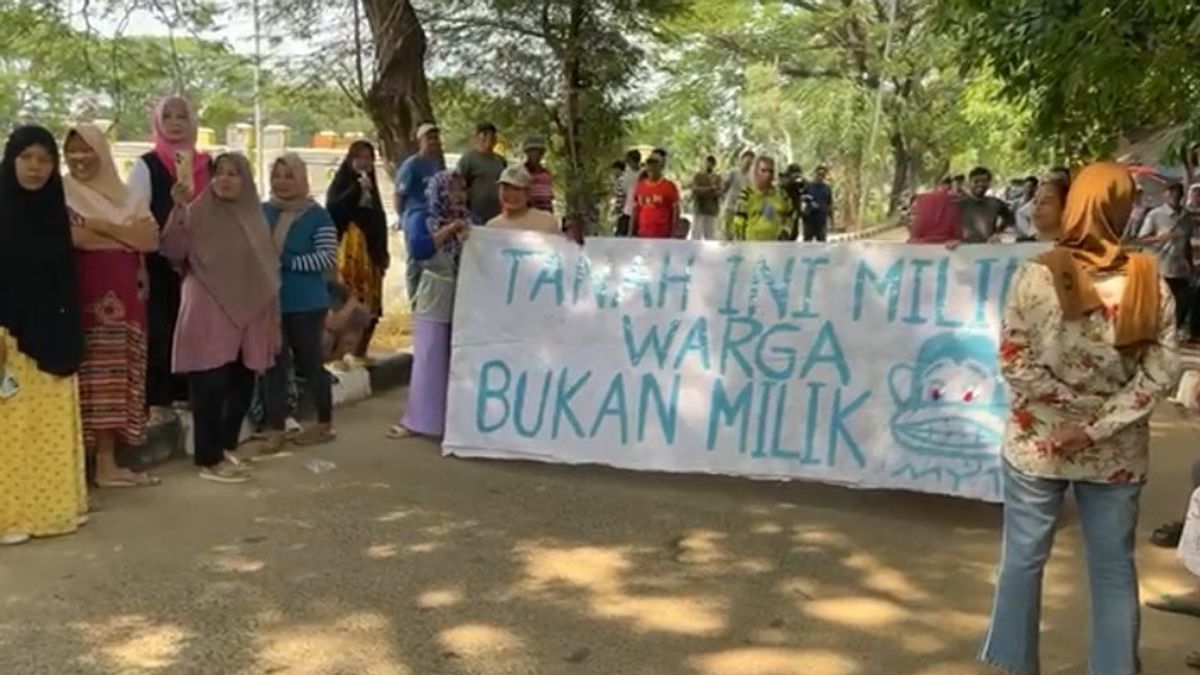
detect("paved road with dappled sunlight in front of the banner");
top-left (0, 395), bottom-right (1196, 675)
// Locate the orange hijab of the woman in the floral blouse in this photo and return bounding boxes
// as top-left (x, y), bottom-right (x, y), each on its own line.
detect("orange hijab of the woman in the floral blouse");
top-left (1038, 162), bottom-right (1159, 347)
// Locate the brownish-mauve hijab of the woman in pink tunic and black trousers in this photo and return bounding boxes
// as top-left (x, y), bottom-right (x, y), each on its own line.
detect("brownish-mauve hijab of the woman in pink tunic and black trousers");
top-left (187, 154), bottom-right (280, 328)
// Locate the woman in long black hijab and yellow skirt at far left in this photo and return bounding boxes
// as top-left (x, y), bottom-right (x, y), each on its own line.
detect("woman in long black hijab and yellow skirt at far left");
top-left (0, 126), bottom-right (88, 545)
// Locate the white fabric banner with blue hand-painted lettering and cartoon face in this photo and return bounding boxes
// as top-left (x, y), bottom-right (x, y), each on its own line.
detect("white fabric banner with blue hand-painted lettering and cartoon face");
top-left (443, 228), bottom-right (1039, 501)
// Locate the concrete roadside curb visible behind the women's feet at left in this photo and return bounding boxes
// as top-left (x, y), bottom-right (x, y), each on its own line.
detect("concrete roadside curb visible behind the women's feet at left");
top-left (118, 352), bottom-right (413, 470)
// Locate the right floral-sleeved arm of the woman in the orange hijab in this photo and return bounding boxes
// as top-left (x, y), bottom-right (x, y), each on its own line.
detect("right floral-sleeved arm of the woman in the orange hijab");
top-left (1084, 282), bottom-right (1180, 442)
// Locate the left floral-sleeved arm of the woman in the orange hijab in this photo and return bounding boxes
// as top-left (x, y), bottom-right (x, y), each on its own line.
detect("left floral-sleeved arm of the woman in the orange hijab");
top-left (1000, 263), bottom-right (1079, 405)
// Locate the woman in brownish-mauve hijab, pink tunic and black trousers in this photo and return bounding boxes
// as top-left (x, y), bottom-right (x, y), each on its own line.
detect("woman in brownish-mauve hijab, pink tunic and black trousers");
top-left (162, 154), bottom-right (281, 483)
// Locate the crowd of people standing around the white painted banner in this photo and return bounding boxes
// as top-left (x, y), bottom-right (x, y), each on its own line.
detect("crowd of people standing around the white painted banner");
top-left (7, 97), bottom-right (1200, 675)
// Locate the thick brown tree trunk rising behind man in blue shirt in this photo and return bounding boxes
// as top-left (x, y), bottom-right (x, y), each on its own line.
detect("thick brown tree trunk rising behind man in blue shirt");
top-left (355, 0), bottom-right (434, 166)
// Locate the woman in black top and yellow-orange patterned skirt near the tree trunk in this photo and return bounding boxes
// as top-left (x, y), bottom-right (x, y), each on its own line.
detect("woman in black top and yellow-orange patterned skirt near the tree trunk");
top-left (325, 141), bottom-right (391, 359)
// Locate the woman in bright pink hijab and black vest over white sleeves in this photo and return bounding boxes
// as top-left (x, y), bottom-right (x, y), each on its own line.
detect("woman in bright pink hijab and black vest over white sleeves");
top-left (128, 96), bottom-right (210, 420)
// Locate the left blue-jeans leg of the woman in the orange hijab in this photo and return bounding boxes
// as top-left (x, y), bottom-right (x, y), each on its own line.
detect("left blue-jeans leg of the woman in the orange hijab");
top-left (979, 464), bottom-right (1067, 675)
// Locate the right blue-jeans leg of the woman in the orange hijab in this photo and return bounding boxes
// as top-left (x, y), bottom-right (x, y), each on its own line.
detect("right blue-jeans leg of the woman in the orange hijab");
top-left (1075, 483), bottom-right (1141, 675)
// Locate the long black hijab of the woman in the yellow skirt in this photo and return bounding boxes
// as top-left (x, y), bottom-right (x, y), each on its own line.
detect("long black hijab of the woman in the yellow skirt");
top-left (0, 126), bottom-right (83, 376)
